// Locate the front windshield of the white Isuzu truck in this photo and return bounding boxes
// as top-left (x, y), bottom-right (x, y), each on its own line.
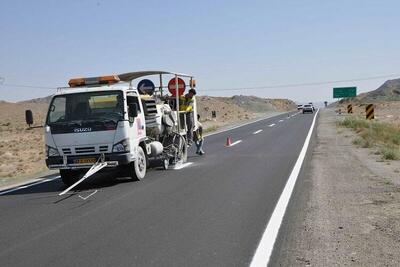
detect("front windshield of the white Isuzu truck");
top-left (47, 91), bottom-right (124, 126)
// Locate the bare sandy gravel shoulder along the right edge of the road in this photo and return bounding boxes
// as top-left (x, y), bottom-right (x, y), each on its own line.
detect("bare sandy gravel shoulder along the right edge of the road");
top-left (276, 109), bottom-right (400, 266)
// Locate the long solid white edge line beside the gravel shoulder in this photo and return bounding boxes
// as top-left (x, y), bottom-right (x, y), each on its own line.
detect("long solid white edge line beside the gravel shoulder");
top-left (250, 111), bottom-right (318, 267)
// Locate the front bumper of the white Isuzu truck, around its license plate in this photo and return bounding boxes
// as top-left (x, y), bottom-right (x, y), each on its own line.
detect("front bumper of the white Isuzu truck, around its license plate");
top-left (46, 153), bottom-right (132, 169)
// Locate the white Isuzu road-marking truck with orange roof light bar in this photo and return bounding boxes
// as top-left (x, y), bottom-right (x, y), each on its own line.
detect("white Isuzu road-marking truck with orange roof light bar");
top-left (44, 71), bottom-right (197, 186)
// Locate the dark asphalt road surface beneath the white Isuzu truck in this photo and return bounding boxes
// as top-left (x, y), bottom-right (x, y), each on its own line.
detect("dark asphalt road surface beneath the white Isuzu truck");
top-left (0, 113), bottom-right (314, 266)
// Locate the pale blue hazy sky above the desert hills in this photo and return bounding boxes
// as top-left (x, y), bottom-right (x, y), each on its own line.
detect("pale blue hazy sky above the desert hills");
top-left (0, 0), bottom-right (400, 101)
